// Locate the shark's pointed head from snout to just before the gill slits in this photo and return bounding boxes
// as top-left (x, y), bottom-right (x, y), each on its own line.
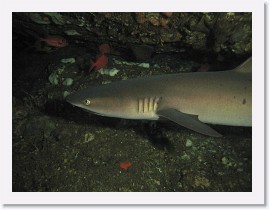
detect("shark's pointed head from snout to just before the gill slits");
top-left (66, 83), bottom-right (155, 119)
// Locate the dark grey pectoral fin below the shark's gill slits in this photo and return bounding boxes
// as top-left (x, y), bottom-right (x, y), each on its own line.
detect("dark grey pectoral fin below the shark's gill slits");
top-left (157, 108), bottom-right (222, 137)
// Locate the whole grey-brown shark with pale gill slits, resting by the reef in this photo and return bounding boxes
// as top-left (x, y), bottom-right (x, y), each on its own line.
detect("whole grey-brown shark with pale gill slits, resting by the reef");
top-left (66, 57), bottom-right (252, 137)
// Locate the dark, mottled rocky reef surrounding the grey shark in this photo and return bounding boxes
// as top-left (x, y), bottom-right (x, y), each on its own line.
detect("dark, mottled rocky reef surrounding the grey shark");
top-left (12, 12), bottom-right (252, 192)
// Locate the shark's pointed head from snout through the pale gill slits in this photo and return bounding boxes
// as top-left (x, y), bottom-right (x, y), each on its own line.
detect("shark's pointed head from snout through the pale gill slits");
top-left (66, 81), bottom-right (159, 119)
